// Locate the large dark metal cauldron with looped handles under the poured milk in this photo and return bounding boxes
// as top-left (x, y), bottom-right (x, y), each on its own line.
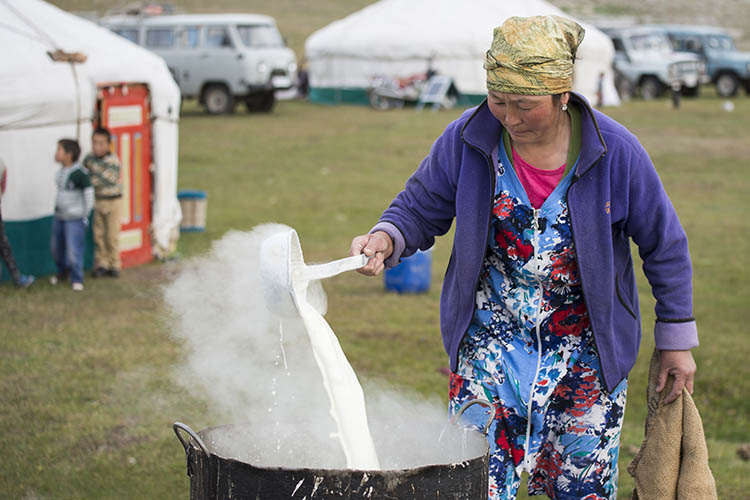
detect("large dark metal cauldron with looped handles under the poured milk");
top-left (173, 400), bottom-right (495, 500)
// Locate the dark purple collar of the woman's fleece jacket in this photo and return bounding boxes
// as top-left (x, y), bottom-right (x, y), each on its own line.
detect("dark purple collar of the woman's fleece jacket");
top-left (461, 92), bottom-right (607, 177)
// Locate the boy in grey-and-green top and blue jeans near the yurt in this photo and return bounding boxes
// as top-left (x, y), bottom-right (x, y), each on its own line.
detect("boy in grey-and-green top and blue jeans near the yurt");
top-left (50, 139), bottom-right (94, 292)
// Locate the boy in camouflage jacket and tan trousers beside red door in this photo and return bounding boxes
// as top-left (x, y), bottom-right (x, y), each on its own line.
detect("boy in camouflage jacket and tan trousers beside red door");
top-left (83, 127), bottom-right (122, 278)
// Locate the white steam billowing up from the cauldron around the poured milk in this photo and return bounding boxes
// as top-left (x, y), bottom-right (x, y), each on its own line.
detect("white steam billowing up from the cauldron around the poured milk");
top-left (165, 224), bottom-right (484, 469)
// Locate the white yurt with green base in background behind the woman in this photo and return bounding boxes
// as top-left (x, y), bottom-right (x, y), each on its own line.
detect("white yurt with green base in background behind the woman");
top-left (305, 0), bottom-right (619, 105)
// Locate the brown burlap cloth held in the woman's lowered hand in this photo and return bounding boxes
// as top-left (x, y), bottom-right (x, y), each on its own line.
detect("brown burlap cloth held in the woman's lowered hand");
top-left (628, 351), bottom-right (717, 500)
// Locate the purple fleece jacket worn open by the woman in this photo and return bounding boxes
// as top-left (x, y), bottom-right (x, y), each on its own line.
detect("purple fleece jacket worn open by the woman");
top-left (372, 93), bottom-right (698, 390)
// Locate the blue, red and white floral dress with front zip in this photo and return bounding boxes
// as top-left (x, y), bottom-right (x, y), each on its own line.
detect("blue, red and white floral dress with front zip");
top-left (450, 144), bottom-right (627, 500)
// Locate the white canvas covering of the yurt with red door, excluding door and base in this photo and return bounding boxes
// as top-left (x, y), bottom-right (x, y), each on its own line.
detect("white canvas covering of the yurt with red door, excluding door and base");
top-left (0, 0), bottom-right (181, 255)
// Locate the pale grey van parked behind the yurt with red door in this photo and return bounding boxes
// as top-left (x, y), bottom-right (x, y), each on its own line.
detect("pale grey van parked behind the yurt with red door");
top-left (100, 14), bottom-right (297, 114)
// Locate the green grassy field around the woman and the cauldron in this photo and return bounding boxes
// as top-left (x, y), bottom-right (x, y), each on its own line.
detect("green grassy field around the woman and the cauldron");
top-left (0, 86), bottom-right (750, 499)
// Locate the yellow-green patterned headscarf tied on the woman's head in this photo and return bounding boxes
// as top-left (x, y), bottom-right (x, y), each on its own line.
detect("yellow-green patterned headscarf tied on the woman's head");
top-left (484, 16), bottom-right (585, 95)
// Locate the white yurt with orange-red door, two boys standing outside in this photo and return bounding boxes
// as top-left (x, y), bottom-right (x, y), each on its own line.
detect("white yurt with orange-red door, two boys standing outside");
top-left (0, 0), bottom-right (181, 278)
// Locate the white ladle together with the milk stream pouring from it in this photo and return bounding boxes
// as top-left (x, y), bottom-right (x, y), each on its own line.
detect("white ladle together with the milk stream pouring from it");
top-left (260, 228), bottom-right (380, 470)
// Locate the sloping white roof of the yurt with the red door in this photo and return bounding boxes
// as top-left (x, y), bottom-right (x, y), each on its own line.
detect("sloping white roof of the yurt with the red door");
top-left (0, 0), bottom-right (180, 128)
